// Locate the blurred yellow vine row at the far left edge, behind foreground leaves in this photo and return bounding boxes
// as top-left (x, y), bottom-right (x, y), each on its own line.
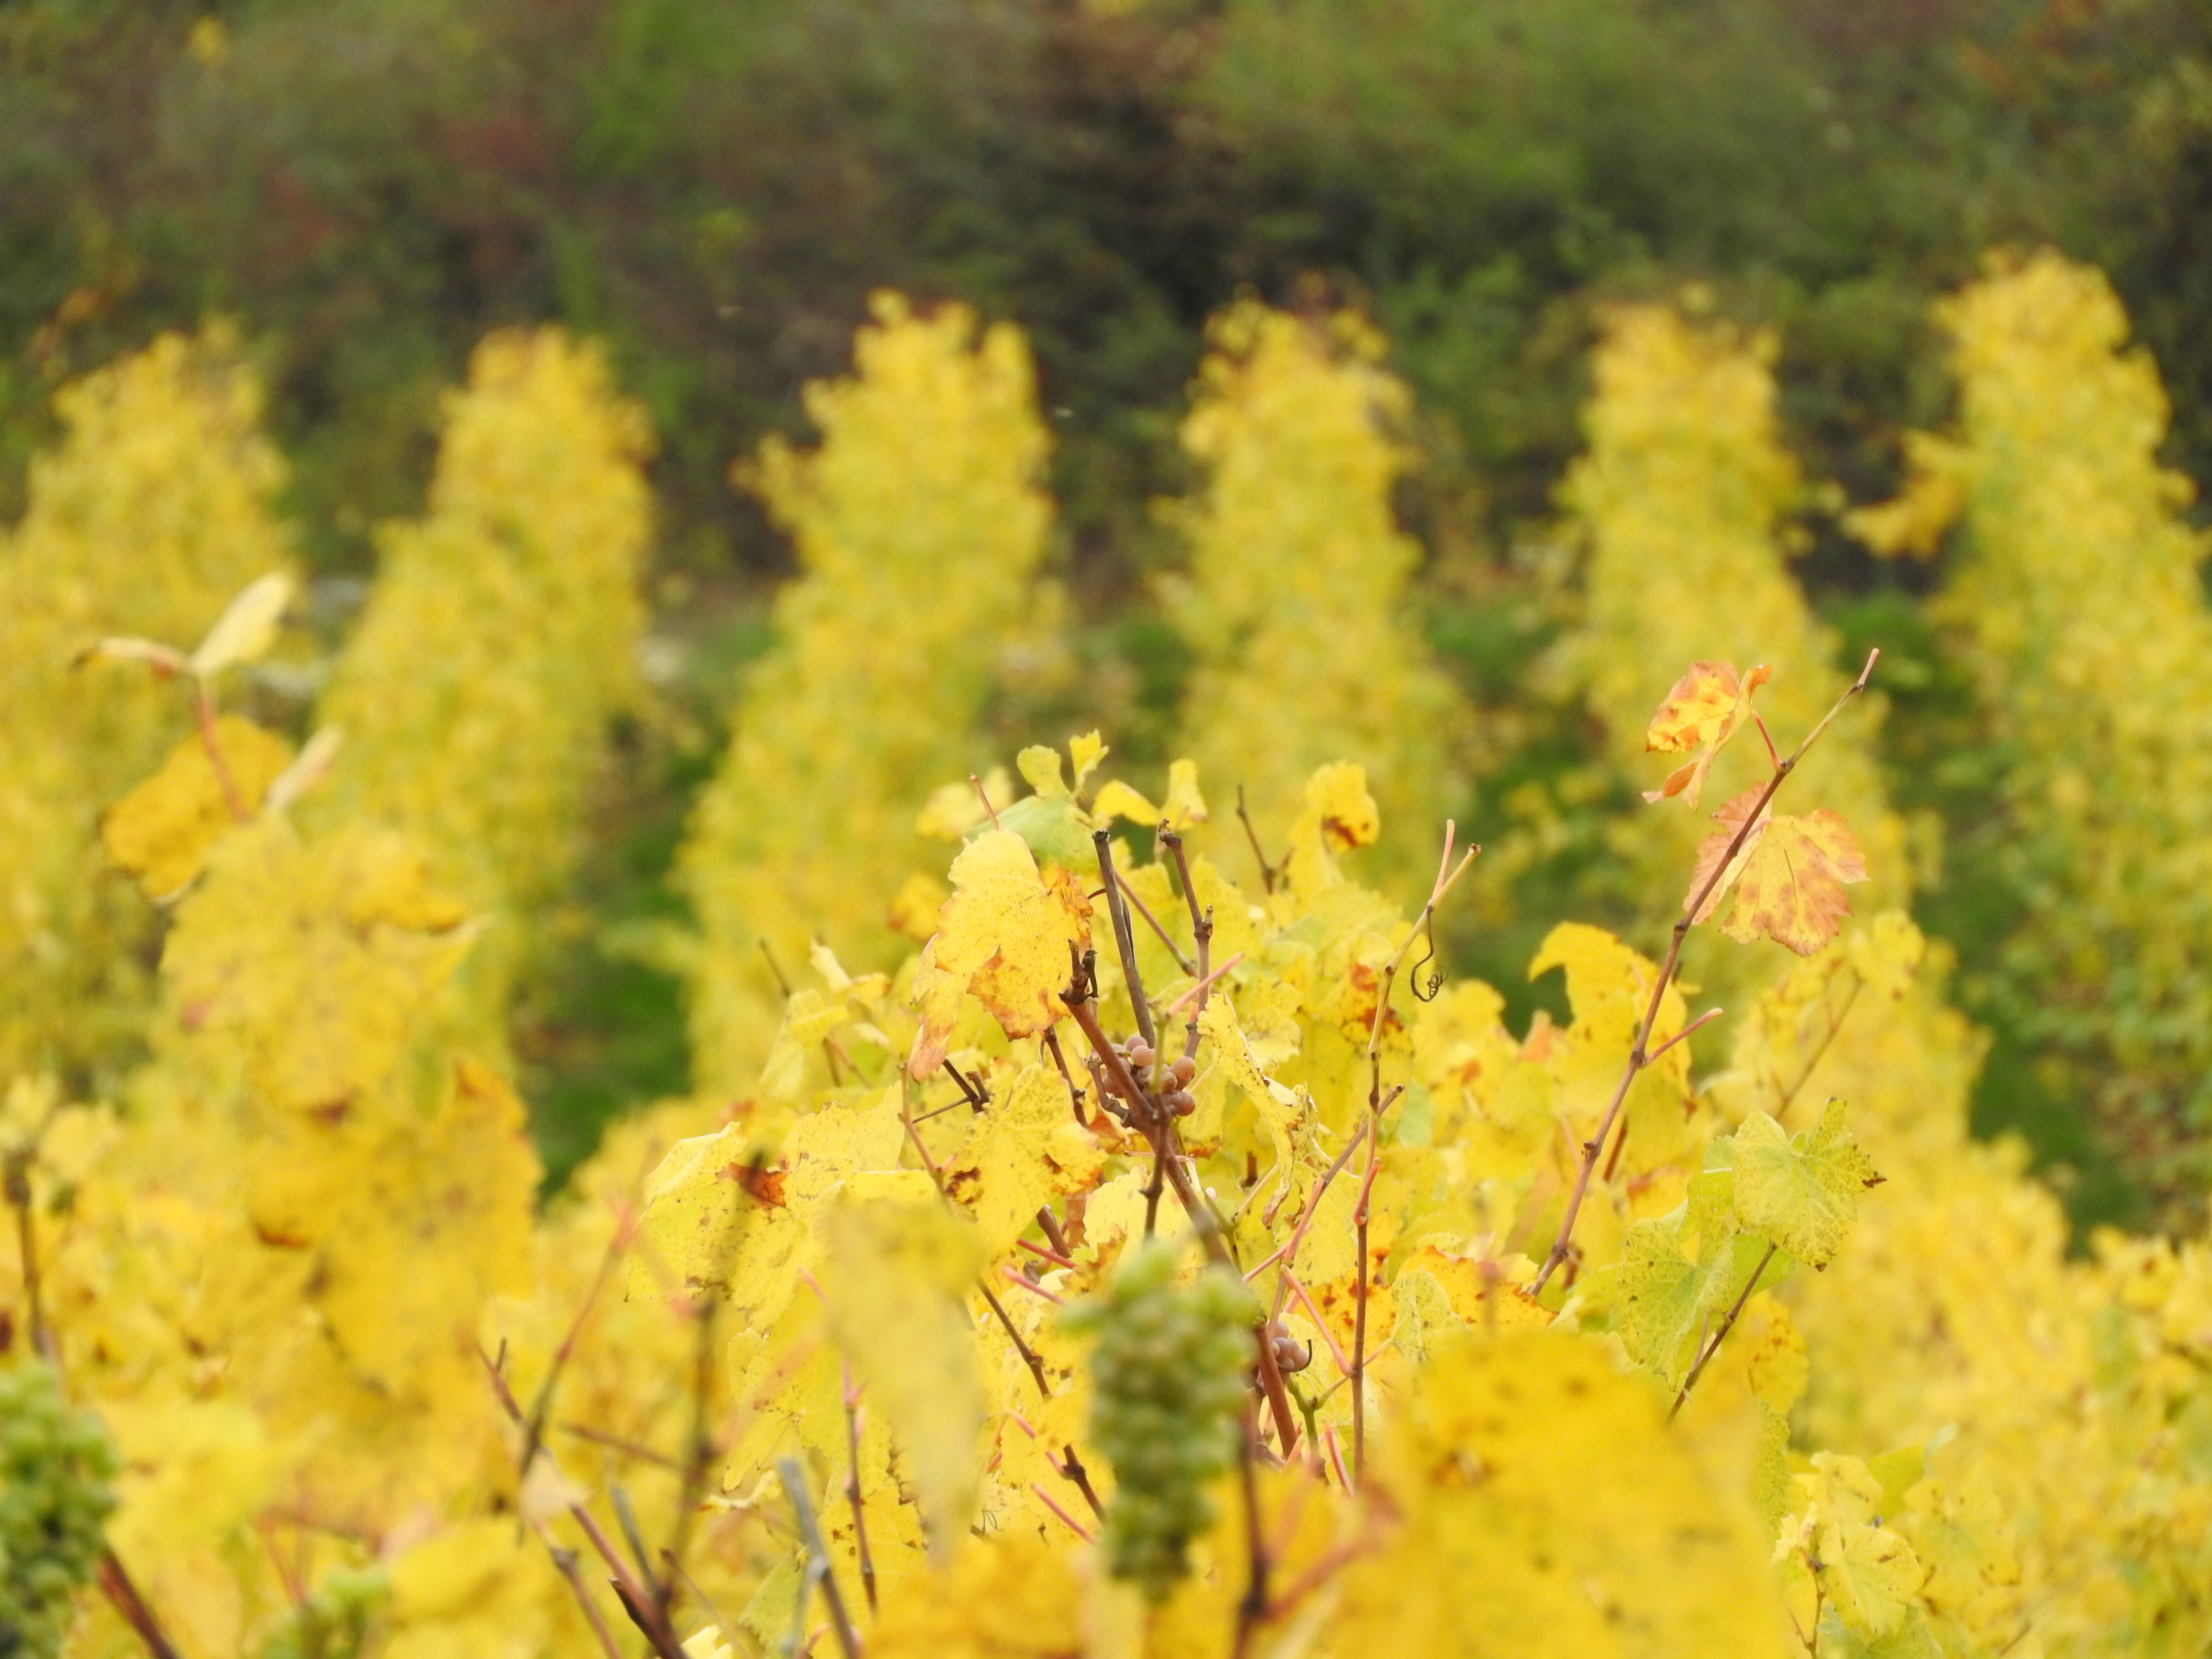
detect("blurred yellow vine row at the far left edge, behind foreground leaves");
top-left (0, 330), bottom-right (290, 1077)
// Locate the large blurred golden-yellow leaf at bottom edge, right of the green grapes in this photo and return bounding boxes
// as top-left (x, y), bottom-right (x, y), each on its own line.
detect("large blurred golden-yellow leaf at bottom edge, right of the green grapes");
top-left (1332, 1332), bottom-right (1787, 1659)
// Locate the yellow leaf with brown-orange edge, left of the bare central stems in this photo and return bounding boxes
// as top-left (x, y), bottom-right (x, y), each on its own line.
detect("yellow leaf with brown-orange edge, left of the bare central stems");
top-left (907, 830), bottom-right (1091, 1077)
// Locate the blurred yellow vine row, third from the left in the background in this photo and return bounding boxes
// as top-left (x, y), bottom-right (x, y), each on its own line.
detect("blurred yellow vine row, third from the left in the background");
top-left (681, 294), bottom-right (1051, 1097)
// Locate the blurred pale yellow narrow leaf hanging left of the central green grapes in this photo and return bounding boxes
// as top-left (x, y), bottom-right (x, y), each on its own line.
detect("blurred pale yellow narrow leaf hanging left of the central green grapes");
top-left (816, 1185), bottom-right (982, 1557)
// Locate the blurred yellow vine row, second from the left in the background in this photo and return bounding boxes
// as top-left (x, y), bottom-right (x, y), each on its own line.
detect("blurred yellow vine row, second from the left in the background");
top-left (316, 330), bottom-right (650, 1051)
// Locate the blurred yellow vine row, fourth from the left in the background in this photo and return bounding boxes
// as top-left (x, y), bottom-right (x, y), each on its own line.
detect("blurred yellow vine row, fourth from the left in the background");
top-left (1168, 301), bottom-right (1467, 898)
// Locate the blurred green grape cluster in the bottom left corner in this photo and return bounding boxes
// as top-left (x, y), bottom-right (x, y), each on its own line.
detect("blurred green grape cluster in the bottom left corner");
top-left (0, 1360), bottom-right (115, 1659)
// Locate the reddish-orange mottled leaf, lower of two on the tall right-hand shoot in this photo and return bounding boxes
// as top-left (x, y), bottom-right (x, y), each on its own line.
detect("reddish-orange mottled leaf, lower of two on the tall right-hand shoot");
top-left (1683, 787), bottom-right (1867, 956)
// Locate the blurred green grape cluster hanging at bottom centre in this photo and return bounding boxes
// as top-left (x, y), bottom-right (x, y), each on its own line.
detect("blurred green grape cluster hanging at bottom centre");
top-left (1069, 1238), bottom-right (1259, 1601)
